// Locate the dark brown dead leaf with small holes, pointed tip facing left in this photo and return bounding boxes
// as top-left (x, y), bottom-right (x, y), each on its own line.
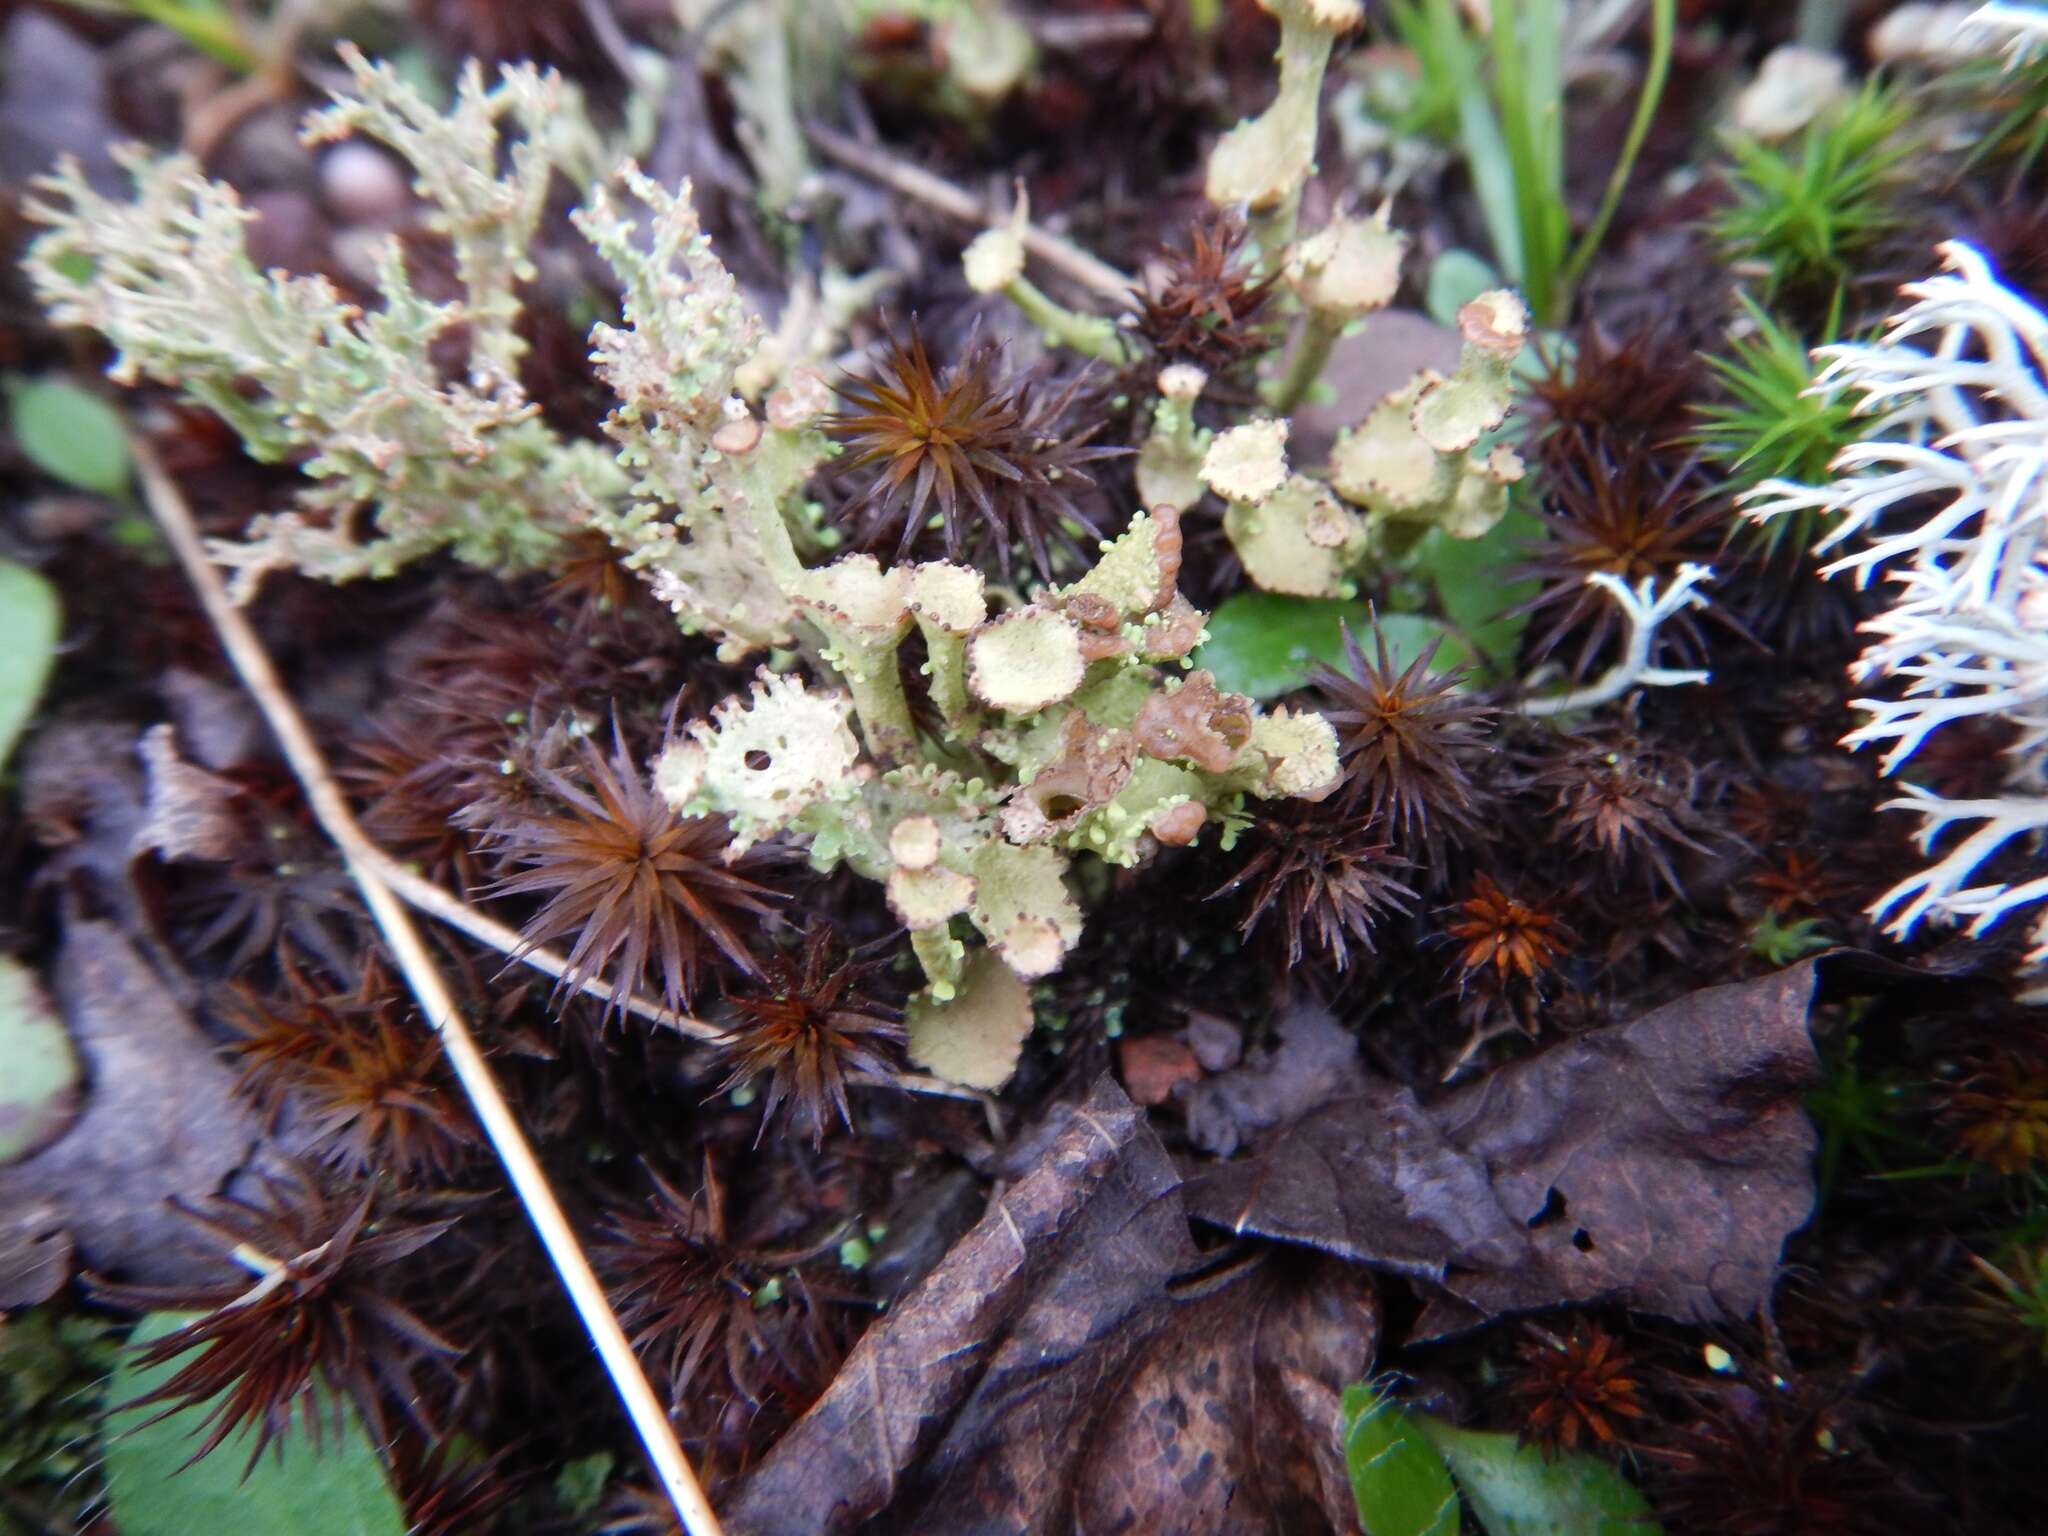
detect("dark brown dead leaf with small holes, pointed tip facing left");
top-left (1188, 961), bottom-right (1821, 1337)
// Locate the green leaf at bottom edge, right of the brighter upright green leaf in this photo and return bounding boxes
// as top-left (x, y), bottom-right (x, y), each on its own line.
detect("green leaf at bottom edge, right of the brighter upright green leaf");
top-left (1413, 1415), bottom-right (1663, 1536)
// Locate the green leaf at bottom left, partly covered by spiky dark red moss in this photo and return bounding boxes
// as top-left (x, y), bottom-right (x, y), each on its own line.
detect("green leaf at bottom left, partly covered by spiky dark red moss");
top-left (104, 1313), bottom-right (406, 1536)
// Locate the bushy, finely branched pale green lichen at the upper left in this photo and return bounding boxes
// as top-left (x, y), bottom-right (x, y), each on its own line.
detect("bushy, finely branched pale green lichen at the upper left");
top-left (27, 49), bottom-right (618, 598)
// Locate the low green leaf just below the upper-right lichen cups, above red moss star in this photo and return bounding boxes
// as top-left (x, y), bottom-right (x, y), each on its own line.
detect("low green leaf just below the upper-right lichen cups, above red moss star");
top-left (1194, 592), bottom-right (1473, 698)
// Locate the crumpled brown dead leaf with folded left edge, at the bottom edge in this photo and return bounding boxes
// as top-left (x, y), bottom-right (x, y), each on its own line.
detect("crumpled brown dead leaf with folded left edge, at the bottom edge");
top-left (725, 1079), bottom-right (1378, 1536)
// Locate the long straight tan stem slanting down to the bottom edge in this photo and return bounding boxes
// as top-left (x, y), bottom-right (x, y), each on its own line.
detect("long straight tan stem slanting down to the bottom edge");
top-left (133, 438), bottom-right (721, 1536)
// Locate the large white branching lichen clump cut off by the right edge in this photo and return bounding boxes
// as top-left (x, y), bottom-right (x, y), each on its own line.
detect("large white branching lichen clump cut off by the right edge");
top-left (1745, 242), bottom-right (2048, 965)
